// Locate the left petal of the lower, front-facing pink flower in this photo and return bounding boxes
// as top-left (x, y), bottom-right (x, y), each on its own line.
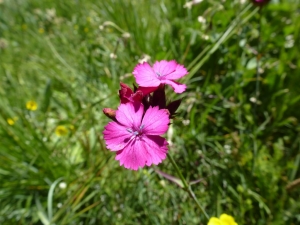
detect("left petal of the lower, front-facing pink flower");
top-left (103, 122), bottom-right (132, 151)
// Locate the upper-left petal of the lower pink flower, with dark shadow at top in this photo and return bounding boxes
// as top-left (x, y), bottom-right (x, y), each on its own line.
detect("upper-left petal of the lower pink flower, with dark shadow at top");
top-left (116, 102), bottom-right (144, 129)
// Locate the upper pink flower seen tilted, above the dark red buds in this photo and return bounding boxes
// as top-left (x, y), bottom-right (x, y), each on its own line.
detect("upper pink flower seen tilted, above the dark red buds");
top-left (133, 60), bottom-right (188, 94)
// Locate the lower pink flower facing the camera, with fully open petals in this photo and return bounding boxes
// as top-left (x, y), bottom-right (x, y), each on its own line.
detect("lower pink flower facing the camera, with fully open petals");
top-left (103, 102), bottom-right (170, 170)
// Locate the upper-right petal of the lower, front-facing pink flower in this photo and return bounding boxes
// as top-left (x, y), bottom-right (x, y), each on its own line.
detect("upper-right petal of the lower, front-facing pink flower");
top-left (141, 106), bottom-right (170, 135)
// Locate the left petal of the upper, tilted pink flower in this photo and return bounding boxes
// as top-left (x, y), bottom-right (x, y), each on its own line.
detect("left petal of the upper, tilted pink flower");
top-left (133, 62), bottom-right (160, 87)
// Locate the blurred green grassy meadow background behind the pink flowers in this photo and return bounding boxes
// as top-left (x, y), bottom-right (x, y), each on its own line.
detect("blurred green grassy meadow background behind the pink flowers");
top-left (0, 0), bottom-right (300, 225)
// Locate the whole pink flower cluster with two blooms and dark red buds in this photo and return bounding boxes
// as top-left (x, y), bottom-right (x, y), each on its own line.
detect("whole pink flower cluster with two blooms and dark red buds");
top-left (103, 60), bottom-right (188, 170)
